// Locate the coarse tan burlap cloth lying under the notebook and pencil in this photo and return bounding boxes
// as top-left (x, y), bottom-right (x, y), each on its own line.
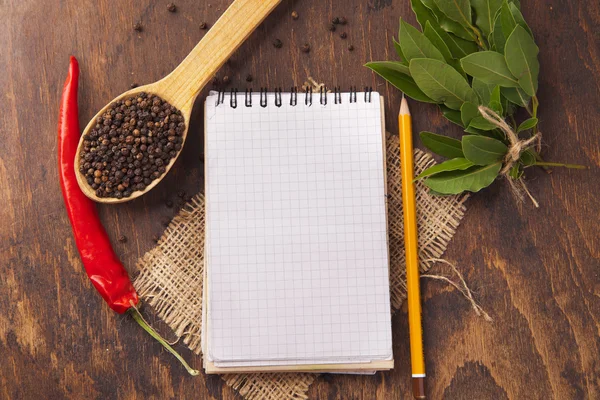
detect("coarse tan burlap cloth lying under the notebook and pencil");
top-left (134, 134), bottom-right (467, 400)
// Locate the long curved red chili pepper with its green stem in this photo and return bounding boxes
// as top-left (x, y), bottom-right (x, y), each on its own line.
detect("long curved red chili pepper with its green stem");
top-left (58, 57), bottom-right (199, 375)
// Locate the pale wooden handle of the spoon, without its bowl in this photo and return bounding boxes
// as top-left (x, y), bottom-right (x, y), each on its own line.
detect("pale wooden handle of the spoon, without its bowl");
top-left (159, 0), bottom-right (281, 109)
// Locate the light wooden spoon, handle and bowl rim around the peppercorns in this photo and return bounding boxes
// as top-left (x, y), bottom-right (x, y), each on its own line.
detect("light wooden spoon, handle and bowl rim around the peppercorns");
top-left (75, 0), bottom-right (281, 203)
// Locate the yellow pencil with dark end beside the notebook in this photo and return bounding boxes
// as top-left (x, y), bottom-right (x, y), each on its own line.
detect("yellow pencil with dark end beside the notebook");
top-left (398, 95), bottom-right (425, 399)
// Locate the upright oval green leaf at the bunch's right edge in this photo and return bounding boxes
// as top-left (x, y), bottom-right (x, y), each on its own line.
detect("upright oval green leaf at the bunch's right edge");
top-left (504, 26), bottom-right (540, 96)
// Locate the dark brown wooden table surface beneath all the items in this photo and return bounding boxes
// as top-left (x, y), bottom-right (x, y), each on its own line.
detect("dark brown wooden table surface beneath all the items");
top-left (0, 0), bottom-right (600, 400)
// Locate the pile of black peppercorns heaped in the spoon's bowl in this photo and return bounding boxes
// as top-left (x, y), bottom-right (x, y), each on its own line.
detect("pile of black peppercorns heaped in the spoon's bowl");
top-left (79, 93), bottom-right (185, 199)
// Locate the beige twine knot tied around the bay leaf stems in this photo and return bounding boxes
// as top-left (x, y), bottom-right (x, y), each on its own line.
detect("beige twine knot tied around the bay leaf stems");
top-left (479, 106), bottom-right (542, 207)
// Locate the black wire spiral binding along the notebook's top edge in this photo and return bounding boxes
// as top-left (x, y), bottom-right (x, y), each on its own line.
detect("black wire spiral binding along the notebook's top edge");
top-left (217, 86), bottom-right (373, 108)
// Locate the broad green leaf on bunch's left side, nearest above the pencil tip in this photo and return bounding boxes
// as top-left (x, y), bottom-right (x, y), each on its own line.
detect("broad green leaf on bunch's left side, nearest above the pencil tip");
top-left (409, 58), bottom-right (479, 110)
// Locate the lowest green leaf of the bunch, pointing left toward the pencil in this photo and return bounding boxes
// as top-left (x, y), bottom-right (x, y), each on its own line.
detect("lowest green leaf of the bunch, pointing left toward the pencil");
top-left (425, 162), bottom-right (502, 194)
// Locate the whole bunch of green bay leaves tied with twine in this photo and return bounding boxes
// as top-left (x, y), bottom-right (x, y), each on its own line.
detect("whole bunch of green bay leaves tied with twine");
top-left (366, 0), bottom-right (579, 195)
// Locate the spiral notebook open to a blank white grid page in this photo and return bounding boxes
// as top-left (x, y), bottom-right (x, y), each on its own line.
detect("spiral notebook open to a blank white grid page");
top-left (202, 90), bottom-right (393, 373)
